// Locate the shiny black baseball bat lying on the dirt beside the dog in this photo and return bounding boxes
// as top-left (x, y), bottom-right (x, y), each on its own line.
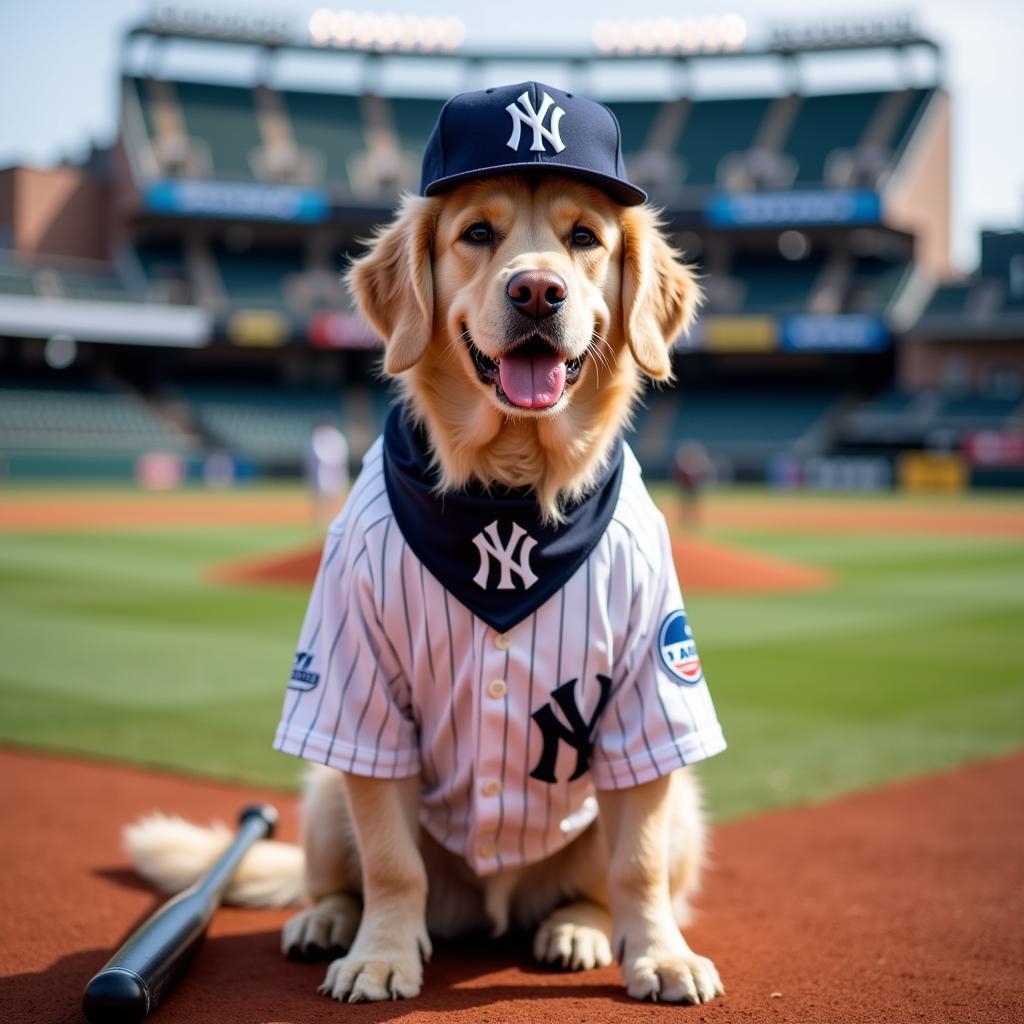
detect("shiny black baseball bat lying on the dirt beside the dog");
top-left (82, 804), bottom-right (278, 1024)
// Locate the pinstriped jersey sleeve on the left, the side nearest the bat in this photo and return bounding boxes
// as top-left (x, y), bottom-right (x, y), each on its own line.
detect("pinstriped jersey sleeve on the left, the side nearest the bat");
top-left (273, 524), bottom-right (420, 778)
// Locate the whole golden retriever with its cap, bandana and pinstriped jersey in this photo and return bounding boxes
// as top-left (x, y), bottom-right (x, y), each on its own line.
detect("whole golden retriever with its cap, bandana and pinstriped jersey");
top-left (126, 83), bottom-right (724, 1004)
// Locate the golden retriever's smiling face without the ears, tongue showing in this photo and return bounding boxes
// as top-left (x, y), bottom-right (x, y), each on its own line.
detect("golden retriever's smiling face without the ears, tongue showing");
top-left (434, 178), bottom-right (623, 417)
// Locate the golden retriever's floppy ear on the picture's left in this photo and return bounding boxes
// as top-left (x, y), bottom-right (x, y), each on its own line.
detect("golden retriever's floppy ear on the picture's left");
top-left (345, 196), bottom-right (435, 374)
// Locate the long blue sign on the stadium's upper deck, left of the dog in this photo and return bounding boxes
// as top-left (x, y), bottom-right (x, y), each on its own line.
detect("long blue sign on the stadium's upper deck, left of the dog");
top-left (142, 179), bottom-right (331, 224)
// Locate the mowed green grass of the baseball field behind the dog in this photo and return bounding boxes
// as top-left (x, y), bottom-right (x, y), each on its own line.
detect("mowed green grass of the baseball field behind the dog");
top-left (0, 483), bottom-right (1024, 818)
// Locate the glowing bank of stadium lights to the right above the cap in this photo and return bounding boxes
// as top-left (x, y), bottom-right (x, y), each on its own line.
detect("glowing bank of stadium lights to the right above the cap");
top-left (593, 13), bottom-right (746, 56)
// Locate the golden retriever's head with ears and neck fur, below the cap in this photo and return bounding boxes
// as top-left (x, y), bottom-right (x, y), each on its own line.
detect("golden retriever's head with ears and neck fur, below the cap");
top-left (348, 174), bottom-right (699, 515)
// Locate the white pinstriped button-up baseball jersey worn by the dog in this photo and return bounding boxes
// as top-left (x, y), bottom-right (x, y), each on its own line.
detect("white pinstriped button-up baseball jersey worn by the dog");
top-left (274, 439), bottom-right (725, 876)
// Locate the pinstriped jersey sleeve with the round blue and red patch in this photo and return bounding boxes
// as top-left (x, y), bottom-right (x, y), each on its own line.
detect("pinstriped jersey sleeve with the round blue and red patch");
top-left (591, 516), bottom-right (725, 790)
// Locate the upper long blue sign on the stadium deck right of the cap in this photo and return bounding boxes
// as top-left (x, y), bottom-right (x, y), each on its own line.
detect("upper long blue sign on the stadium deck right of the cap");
top-left (705, 189), bottom-right (882, 227)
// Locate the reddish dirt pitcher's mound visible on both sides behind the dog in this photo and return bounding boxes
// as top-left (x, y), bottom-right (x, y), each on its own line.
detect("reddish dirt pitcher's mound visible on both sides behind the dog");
top-left (209, 537), bottom-right (831, 594)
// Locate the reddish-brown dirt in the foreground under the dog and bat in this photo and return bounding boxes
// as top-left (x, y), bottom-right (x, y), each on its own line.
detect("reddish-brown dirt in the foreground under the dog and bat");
top-left (0, 751), bottom-right (1024, 1024)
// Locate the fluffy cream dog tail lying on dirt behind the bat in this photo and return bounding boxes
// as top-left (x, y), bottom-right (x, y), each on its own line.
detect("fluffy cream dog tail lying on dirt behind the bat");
top-left (124, 813), bottom-right (304, 907)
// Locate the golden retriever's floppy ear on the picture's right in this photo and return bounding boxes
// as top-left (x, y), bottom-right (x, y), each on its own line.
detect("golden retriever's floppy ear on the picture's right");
top-left (622, 206), bottom-right (700, 380)
